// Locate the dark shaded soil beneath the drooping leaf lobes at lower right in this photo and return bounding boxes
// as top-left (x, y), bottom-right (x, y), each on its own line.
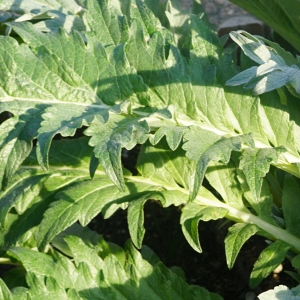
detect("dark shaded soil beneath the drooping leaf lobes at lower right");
top-left (91, 201), bottom-right (297, 300)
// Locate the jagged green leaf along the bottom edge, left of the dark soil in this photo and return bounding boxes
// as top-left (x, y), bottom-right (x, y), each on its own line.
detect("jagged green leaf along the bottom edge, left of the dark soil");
top-left (0, 236), bottom-right (222, 300)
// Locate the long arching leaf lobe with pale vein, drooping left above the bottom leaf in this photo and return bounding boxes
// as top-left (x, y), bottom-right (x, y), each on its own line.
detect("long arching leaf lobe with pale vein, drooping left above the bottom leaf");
top-left (38, 172), bottom-right (182, 249)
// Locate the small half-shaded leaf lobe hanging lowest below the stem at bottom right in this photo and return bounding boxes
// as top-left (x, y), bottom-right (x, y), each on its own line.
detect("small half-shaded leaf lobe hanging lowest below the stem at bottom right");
top-left (250, 240), bottom-right (291, 288)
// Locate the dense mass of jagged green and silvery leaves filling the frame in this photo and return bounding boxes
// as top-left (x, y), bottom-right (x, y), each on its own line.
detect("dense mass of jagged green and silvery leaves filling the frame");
top-left (0, 0), bottom-right (300, 300)
